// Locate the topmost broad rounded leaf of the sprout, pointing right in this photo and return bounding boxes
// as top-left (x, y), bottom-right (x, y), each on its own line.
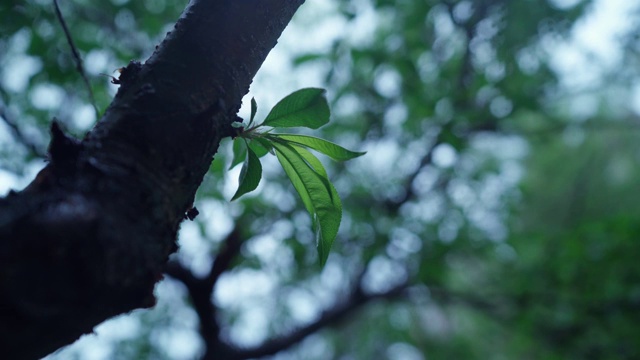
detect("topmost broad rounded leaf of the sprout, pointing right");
top-left (262, 88), bottom-right (330, 129)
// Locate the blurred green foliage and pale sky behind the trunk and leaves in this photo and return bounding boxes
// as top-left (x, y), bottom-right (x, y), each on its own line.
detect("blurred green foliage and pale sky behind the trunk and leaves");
top-left (0, 0), bottom-right (640, 360)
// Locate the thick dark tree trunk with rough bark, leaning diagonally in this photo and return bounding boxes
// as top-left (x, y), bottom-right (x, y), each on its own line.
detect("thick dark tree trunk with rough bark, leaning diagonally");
top-left (0, 0), bottom-right (303, 359)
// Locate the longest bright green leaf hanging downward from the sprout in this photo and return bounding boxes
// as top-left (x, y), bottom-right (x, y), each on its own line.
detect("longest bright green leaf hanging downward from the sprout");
top-left (273, 142), bottom-right (342, 266)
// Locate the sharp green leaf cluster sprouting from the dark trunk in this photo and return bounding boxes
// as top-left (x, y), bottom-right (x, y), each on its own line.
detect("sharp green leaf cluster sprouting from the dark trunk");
top-left (230, 88), bottom-right (364, 266)
